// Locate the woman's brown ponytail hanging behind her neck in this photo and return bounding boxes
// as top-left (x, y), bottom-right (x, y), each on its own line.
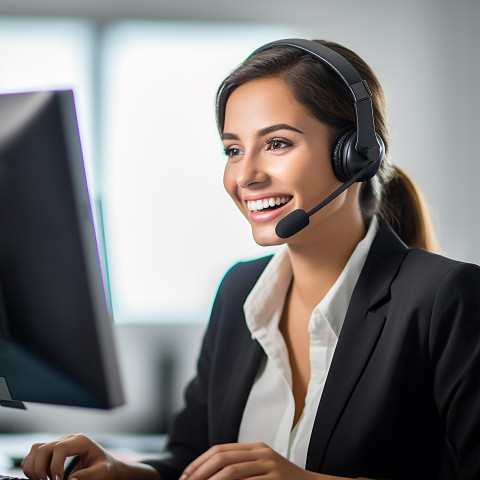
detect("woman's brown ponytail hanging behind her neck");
top-left (379, 165), bottom-right (439, 252)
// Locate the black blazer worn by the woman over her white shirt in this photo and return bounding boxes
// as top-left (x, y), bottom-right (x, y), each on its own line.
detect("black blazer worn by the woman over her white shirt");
top-left (148, 222), bottom-right (480, 480)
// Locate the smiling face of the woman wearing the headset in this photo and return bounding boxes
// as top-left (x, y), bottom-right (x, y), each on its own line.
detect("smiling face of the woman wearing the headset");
top-left (222, 78), bottom-right (358, 245)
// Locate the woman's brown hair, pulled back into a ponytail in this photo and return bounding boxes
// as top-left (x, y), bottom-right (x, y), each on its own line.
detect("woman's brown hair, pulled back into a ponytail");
top-left (216, 40), bottom-right (437, 251)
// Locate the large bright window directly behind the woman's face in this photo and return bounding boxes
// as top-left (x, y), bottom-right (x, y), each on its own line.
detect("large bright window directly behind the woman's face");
top-left (103, 23), bottom-right (304, 321)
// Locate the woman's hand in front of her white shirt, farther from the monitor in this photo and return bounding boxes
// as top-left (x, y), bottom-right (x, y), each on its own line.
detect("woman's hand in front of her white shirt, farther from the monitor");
top-left (180, 443), bottom-right (322, 480)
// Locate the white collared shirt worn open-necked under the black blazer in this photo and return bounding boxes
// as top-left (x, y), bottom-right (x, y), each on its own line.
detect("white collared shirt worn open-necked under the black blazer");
top-left (238, 218), bottom-right (378, 468)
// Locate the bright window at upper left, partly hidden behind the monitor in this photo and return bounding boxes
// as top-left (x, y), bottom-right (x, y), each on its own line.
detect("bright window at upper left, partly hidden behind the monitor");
top-left (0, 18), bottom-right (94, 188)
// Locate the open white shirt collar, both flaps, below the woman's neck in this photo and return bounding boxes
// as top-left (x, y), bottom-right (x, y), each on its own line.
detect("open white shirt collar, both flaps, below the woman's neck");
top-left (243, 217), bottom-right (378, 337)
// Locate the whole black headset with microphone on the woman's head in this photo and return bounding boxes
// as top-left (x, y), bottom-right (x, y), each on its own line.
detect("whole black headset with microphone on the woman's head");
top-left (250, 38), bottom-right (385, 238)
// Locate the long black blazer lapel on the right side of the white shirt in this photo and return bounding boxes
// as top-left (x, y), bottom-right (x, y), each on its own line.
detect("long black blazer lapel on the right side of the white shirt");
top-left (306, 222), bottom-right (407, 471)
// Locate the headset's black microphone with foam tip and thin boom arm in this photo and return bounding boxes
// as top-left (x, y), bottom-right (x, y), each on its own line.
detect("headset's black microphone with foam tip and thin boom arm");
top-left (275, 160), bottom-right (378, 238)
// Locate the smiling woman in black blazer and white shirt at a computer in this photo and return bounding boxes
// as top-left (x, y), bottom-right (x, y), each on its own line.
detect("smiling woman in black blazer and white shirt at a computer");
top-left (23, 41), bottom-right (480, 480)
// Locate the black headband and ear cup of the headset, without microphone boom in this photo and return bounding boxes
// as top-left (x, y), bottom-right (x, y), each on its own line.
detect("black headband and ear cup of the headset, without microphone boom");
top-left (252, 38), bottom-right (385, 182)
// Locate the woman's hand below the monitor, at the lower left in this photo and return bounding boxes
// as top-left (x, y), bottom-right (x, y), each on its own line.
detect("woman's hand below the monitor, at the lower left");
top-left (22, 434), bottom-right (160, 480)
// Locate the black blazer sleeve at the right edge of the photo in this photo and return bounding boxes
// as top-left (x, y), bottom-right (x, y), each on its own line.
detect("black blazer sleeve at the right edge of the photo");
top-left (429, 264), bottom-right (480, 480)
